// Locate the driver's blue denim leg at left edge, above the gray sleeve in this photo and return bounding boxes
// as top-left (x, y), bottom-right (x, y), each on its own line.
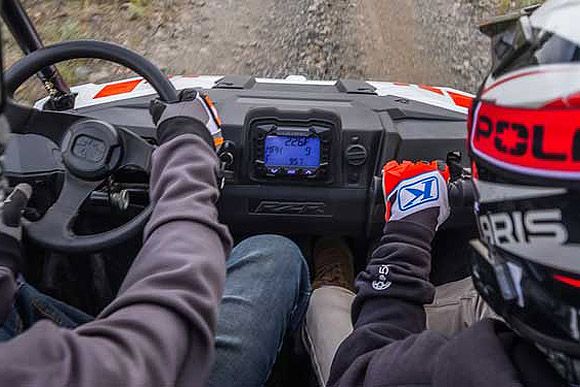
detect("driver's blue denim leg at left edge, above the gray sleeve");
top-left (0, 282), bottom-right (93, 342)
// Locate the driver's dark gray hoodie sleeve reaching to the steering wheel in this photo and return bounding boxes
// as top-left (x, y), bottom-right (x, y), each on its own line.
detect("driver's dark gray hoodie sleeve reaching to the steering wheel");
top-left (0, 135), bottom-right (231, 387)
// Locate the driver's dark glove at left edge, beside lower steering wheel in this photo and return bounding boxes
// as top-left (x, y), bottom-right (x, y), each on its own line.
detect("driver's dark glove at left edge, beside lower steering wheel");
top-left (0, 184), bottom-right (32, 275)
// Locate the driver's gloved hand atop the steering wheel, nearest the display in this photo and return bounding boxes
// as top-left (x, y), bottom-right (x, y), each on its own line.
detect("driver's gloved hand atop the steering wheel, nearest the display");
top-left (149, 89), bottom-right (224, 150)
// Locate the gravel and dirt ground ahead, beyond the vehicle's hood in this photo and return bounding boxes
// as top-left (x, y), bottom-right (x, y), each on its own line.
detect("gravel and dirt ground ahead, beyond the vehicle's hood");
top-left (5, 0), bottom-right (498, 100)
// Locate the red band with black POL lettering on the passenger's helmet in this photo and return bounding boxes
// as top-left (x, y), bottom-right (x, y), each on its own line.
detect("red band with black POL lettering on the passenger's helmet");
top-left (470, 103), bottom-right (580, 178)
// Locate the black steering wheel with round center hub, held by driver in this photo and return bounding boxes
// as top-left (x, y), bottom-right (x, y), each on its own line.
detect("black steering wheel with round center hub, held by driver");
top-left (5, 40), bottom-right (177, 253)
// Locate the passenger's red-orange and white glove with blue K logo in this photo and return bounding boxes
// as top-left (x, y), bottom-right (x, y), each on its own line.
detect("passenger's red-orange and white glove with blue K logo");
top-left (383, 161), bottom-right (450, 229)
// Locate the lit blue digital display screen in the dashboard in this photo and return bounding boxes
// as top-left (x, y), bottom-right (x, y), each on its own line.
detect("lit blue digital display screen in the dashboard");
top-left (264, 136), bottom-right (320, 168)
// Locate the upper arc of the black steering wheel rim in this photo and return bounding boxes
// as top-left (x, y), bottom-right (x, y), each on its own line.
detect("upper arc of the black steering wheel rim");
top-left (4, 40), bottom-right (177, 102)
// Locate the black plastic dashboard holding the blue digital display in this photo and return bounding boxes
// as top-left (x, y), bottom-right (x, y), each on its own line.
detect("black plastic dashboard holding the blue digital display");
top-left (6, 76), bottom-right (466, 239)
